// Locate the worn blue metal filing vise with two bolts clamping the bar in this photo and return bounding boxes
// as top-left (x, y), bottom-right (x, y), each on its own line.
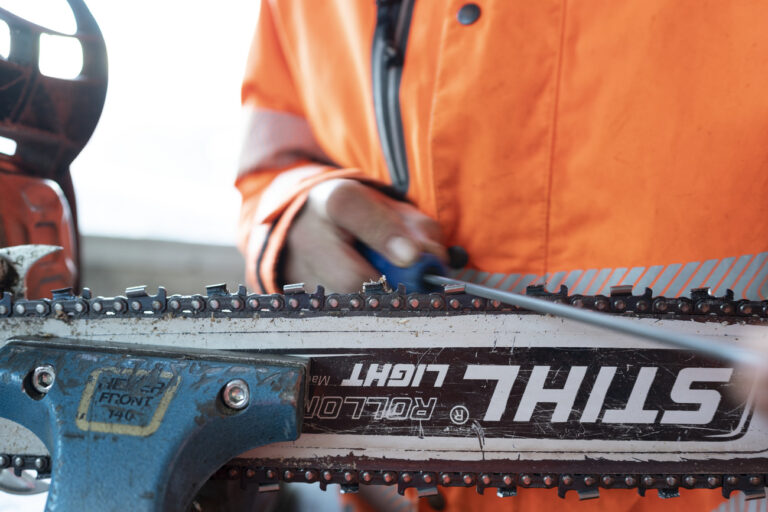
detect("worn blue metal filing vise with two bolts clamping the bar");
top-left (0, 340), bottom-right (307, 512)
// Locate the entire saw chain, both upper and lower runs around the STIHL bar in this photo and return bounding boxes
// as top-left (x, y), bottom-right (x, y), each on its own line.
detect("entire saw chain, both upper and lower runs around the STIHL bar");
top-left (0, 281), bottom-right (768, 499)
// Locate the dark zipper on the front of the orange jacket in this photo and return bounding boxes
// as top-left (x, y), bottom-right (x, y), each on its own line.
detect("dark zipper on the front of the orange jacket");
top-left (371, 0), bottom-right (414, 196)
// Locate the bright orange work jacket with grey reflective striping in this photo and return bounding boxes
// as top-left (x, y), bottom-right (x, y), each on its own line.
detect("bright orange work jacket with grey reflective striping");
top-left (237, 0), bottom-right (768, 510)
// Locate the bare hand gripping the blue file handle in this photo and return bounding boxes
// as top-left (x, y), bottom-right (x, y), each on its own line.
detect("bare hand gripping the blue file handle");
top-left (283, 179), bottom-right (447, 293)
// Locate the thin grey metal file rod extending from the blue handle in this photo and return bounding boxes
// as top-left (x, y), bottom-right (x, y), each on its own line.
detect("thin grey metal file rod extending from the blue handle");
top-left (424, 274), bottom-right (768, 369)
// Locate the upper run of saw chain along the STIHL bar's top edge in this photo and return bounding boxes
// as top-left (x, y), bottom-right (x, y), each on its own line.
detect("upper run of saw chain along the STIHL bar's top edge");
top-left (0, 282), bottom-right (768, 323)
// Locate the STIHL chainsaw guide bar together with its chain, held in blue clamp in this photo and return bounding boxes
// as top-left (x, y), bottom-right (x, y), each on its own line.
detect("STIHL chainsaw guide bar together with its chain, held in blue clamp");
top-left (0, 282), bottom-right (768, 499)
